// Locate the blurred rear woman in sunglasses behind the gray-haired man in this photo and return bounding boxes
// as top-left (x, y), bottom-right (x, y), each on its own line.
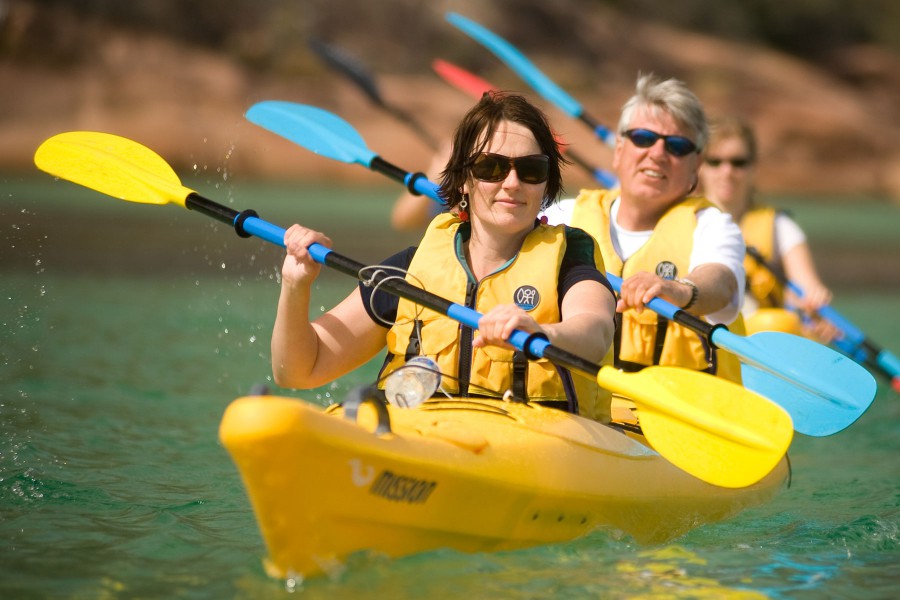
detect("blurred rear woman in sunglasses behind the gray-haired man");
top-left (700, 117), bottom-right (837, 343)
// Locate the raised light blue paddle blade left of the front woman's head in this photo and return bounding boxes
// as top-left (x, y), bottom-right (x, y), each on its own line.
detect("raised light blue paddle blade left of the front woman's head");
top-left (244, 100), bottom-right (376, 167)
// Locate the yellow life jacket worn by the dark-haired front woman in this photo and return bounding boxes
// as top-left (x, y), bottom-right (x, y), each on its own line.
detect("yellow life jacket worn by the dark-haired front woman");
top-left (381, 213), bottom-right (612, 422)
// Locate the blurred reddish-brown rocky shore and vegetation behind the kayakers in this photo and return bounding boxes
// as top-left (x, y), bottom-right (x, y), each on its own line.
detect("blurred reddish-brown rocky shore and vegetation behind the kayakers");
top-left (0, 0), bottom-right (900, 202)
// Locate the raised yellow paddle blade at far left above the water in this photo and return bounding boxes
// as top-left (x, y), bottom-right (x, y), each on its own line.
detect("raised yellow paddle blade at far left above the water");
top-left (34, 131), bottom-right (193, 206)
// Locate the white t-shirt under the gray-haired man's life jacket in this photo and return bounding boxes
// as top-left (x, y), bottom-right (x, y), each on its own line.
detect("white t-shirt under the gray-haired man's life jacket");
top-left (542, 198), bottom-right (747, 325)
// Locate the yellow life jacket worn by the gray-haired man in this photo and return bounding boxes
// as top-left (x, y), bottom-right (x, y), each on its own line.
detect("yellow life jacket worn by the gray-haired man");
top-left (572, 190), bottom-right (744, 382)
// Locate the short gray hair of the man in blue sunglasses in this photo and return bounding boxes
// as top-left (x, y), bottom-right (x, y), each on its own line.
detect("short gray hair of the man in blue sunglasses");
top-left (619, 73), bottom-right (709, 150)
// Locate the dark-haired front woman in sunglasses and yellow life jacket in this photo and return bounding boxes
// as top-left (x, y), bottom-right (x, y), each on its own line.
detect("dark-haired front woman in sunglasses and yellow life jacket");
top-left (272, 93), bottom-right (615, 421)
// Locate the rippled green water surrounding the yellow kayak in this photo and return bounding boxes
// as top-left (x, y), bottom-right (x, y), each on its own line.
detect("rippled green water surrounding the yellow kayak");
top-left (0, 178), bottom-right (900, 599)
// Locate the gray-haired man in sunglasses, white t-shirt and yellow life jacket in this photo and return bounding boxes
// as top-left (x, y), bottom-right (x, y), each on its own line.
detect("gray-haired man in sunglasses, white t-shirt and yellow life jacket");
top-left (546, 75), bottom-right (744, 381)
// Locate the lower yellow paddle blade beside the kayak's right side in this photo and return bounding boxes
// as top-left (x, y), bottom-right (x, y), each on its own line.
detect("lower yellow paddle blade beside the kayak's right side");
top-left (597, 367), bottom-right (794, 488)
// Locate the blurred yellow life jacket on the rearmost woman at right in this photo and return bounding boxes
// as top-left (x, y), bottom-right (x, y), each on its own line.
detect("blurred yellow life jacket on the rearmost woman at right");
top-left (740, 206), bottom-right (784, 308)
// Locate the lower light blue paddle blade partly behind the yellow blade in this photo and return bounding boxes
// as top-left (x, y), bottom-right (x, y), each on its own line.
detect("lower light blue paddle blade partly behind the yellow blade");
top-left (732, 330), bottom-right (877, 436)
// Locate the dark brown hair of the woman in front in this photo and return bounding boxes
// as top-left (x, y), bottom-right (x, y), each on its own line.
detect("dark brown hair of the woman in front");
top-left (439, 92), bottom-right (569, 208)
